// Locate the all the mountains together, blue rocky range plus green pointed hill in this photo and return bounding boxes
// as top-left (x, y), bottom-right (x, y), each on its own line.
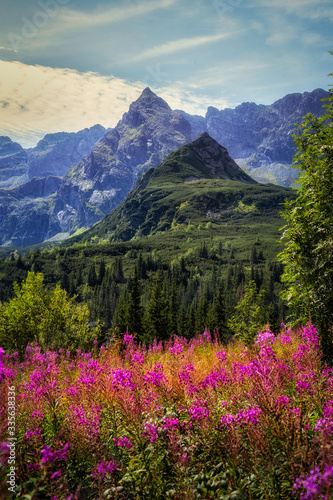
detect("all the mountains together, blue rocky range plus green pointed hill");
top-left (0, 88), bottom-right (328, 248)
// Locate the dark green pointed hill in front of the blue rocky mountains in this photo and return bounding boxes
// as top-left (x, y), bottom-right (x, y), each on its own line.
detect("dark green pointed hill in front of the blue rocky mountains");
top-left (69, 133), bottom-right (291, 243)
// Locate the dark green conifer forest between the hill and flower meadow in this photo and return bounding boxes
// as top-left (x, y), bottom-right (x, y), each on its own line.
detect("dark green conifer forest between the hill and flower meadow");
top-left (0, 241), bottom-right (285, 342)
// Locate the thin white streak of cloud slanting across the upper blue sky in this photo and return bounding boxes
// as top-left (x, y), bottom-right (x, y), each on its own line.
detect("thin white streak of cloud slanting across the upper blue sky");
top-left (124, 33), bottom-right (239, 64)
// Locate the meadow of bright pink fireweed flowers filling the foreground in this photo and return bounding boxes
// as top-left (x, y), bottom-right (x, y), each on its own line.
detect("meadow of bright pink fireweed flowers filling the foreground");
top-left (0, 325), bottom-right (333, 500)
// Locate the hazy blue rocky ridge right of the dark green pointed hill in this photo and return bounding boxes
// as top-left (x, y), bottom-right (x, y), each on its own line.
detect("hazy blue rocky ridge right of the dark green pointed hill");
top-left (206, 89), bottom-right (329, 186)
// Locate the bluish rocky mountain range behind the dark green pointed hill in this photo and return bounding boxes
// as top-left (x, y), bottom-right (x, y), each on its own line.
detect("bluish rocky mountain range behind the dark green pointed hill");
top-left (0, 88), bottom-right (328, 246)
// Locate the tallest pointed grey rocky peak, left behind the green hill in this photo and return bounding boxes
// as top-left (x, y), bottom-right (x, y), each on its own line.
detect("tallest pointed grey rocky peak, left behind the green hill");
top-left (52, 88), bottom-right (191, 236)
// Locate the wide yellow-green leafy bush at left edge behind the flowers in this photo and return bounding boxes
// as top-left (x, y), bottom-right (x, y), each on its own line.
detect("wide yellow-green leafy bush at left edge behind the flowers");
top-left (0, 272), bottom-right (100, 356)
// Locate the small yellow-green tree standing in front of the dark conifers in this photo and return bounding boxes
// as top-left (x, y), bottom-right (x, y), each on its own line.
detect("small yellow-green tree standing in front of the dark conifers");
top-left (228, 281), bottom-right (268, 345)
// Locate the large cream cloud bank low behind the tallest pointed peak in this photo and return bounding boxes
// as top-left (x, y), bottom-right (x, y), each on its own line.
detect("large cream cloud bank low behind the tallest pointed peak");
top-left (0, 60), bottom-right (230, 147)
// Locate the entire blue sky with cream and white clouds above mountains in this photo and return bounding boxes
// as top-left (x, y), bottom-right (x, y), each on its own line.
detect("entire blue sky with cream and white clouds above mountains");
top-left (0, 0), bottom-right (333, 147)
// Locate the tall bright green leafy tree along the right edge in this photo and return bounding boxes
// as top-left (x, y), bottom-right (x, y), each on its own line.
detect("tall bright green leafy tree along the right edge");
top-left (279, 72), bottom-right (333, 357)
